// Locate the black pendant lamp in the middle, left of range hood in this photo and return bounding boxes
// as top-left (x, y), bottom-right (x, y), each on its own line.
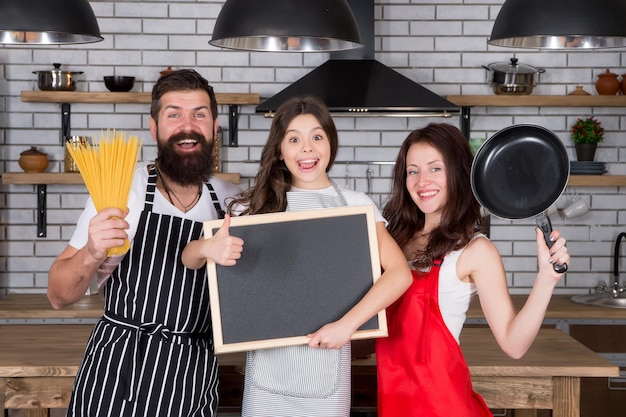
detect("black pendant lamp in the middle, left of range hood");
top-left (209, 0), bottom-right (363, 52)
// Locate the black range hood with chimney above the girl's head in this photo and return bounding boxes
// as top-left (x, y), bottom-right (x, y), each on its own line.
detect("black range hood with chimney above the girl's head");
top-left (256, 0), bottom-right (460, 117)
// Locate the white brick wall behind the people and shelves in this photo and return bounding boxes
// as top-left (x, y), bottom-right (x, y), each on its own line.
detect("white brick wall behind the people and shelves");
top-left (0, 0), bottom-right (626, 295)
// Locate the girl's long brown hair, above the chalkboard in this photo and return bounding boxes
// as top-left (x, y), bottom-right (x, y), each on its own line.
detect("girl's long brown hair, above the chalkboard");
top-left (228, 96), bottom-right (339, 214)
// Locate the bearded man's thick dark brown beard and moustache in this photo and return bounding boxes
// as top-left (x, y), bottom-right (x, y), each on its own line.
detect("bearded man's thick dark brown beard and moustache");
top-left (157, 131), bottom-right (213, 186)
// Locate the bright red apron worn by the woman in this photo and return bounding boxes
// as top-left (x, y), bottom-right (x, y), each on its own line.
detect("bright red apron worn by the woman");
top-left (376, 261), bottom-right (492, 417)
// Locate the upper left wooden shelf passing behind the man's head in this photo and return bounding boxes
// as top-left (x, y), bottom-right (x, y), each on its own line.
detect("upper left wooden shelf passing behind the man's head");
top-left (22, 91), bottom-right (261, 105)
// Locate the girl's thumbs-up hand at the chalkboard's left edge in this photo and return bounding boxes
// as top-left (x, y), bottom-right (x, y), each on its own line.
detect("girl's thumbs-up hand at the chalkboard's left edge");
top-left (182, 214), bottom-right (243, 269)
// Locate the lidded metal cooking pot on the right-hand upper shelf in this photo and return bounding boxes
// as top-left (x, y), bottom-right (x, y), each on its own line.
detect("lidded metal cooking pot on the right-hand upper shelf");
top-left (483, 58), bottom-right (546, 95)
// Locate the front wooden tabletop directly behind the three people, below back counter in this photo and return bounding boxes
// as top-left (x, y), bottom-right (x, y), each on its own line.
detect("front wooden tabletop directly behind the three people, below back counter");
top-left (0, 324), bottom-right (619, 378)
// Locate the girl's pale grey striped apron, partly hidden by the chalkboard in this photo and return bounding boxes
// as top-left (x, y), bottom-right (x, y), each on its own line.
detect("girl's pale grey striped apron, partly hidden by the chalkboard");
top-left (242, 180), bottom-right (352, 417)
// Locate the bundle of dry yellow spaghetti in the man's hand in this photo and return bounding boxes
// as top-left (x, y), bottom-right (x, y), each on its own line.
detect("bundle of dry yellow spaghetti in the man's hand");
top-left (66, 130), bottom-right (141, 256)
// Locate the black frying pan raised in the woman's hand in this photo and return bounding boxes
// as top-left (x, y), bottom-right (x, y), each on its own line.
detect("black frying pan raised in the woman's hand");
top-left (471, 124), bottom-right (569, 272)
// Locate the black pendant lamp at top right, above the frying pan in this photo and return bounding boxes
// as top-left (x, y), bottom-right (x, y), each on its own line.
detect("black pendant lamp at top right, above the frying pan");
top-left (487, 0), bottom-right (626, 49)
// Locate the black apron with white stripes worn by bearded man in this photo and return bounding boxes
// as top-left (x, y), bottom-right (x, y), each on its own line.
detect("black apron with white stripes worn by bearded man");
top-left (67, 167), bottom-right (223, 417)
